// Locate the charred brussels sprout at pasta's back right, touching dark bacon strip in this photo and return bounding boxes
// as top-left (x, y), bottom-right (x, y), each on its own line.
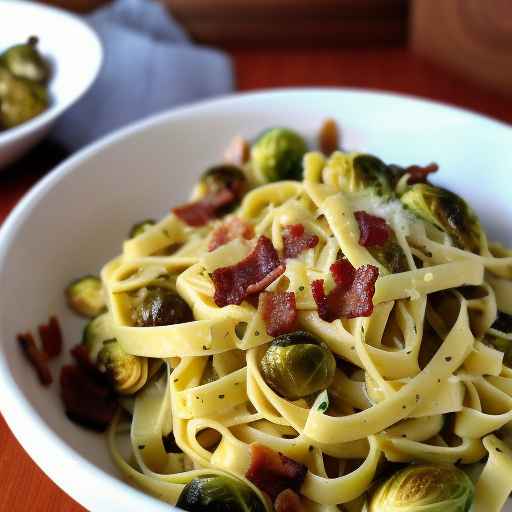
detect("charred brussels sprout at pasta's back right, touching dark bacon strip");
top-left (350, 155), bottom-right (400, 199)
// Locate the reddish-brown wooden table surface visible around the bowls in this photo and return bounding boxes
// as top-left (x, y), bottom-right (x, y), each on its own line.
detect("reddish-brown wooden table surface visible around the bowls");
top-left (0, 49), bottom-right (512, 512)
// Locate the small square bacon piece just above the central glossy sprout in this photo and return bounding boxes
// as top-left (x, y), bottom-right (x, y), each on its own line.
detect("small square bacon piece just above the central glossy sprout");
top-left (260, 292), bottom-right (297, 336)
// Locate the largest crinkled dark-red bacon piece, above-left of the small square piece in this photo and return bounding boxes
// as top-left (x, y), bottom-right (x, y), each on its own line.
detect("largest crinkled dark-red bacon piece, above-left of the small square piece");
top-left (212, 235), bottom-right (285, 308)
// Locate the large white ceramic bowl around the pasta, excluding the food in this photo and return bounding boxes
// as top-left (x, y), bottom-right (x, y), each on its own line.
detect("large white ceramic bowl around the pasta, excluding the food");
top-left (0, 89), bottom-right (512, 512)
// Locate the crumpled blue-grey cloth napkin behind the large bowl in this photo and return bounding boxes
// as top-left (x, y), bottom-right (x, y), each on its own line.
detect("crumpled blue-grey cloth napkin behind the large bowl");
top-left (52, 0), bottom-right (233, 150)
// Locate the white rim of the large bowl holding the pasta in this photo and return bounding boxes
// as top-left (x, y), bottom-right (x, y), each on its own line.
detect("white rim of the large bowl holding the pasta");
top-left (0, 87), bottom-right (512, 512)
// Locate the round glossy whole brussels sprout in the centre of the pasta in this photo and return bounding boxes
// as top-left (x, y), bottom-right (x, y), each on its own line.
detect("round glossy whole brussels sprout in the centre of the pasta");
top-left (260, 331), bottom-right (336, 400)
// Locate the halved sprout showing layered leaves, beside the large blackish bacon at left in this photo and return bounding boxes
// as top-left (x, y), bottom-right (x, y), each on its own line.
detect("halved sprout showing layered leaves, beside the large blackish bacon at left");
top-left (96, 338), bottom-right (145, 393)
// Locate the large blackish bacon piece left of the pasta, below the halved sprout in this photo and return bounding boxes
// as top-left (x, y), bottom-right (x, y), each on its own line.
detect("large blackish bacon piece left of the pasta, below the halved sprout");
top-left (60, 345), bottom-right (117, 432)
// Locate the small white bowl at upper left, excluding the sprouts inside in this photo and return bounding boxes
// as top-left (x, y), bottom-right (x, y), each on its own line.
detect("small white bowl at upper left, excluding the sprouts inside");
top-left (0, 0), bottom-right (103, 170)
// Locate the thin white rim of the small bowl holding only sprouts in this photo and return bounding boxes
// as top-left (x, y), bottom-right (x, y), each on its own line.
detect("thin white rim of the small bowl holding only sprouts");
top-left (0, 0), bottom-right (104, 147)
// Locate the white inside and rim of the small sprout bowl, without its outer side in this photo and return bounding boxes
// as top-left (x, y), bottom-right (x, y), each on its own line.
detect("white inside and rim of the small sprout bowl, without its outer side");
top-left (0, 0), bottom-right (101, 138)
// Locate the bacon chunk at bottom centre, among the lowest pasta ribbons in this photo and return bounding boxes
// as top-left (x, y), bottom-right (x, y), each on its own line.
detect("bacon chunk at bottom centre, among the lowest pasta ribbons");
top-left (245, 443), bottom-right (308, 500)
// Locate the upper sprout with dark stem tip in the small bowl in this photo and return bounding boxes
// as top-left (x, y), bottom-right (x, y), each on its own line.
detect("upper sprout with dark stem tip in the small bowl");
top-left (0, 36), bottom-right (50, 84)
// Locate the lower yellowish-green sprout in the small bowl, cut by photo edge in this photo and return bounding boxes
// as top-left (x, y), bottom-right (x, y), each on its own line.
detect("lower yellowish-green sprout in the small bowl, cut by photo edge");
top-left (0, 66), bottom-right (49, 128)
